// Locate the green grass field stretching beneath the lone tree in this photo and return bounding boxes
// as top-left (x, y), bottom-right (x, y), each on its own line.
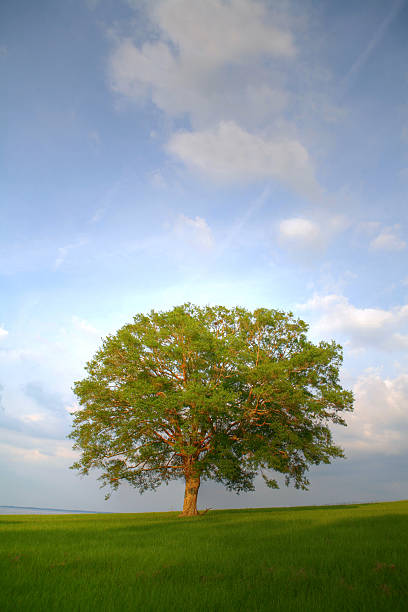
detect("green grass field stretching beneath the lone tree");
top-left (0, 501), bottom-right (408, 612)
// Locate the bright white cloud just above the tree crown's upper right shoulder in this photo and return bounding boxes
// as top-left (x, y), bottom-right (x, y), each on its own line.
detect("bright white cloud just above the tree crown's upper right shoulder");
top-left (299, 294), bottom-right (408, 351)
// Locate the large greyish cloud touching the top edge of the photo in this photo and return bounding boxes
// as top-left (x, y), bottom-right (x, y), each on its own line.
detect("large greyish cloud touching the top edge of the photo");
top-left (110, 0), bottom-right (296, 122)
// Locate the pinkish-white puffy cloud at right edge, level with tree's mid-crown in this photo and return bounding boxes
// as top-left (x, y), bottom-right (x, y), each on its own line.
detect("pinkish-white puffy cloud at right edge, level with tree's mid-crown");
top-left (341, 372), bottom-right (408, 454)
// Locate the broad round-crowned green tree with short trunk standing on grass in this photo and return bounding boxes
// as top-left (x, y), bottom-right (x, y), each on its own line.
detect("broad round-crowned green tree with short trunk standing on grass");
top-left (70, 304), bottom-right (353, 516)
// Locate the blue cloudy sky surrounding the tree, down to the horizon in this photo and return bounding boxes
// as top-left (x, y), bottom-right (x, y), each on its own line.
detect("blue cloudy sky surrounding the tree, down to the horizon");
top-left (0, 0), bottom-right (408, 512)
